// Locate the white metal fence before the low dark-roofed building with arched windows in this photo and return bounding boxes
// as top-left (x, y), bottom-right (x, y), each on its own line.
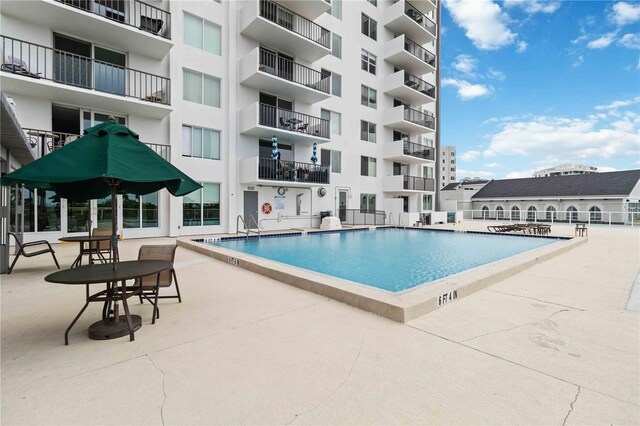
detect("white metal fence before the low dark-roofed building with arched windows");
top-left (462, 209), bottom-right (640, 226)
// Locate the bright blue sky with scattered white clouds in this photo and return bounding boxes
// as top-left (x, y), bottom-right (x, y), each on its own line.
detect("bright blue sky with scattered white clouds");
top-left (439, 0), bottom-right (640, 179)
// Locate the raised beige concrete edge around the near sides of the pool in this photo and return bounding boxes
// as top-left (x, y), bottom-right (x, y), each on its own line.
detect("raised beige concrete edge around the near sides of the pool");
top-left (177, 236), bottom-right (588, 323)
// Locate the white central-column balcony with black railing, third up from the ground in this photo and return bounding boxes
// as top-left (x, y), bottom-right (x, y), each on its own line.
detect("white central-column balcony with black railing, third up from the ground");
top-left (240, 47), bottom-right (331, 104)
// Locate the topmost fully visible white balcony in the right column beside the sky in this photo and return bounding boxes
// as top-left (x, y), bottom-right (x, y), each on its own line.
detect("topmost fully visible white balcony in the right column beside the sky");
top-left (384, 0), bottom-right (438, 44)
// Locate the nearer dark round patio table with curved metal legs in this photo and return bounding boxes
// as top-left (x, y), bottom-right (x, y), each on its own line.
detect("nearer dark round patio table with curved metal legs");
top-left (44, 260), bottom-right (172, 345)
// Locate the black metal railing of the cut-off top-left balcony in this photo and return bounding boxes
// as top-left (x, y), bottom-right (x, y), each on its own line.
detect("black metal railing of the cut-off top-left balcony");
top-left (55, 0), bottom-right (171, 39)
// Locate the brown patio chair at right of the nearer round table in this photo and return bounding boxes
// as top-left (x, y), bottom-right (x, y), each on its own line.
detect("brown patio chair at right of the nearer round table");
top-left (134, 244), bottom-right (182, 324)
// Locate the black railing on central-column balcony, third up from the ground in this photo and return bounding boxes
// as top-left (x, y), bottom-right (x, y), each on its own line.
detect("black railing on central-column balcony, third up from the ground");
top-left (259, 48), bottom-right (331, 93)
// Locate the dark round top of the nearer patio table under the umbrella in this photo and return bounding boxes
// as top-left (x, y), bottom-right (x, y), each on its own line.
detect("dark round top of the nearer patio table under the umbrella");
top-left (44, 260), bottom-right (172, 284)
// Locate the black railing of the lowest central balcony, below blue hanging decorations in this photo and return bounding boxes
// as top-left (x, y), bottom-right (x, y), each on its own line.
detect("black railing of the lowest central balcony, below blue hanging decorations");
top-left (258, 158), bottom-right (329, 184)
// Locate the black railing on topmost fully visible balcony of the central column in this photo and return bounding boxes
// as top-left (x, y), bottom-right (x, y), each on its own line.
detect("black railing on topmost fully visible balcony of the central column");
top-left (260, 0), bottom-right (331, 49)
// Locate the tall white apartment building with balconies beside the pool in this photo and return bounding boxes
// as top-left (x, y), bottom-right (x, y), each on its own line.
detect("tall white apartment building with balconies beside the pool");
top-left (0, 0), bottom-right (440, 241)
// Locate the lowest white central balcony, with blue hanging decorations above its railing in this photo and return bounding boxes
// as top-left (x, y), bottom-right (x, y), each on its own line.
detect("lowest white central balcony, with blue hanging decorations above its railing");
top-left (240, 157), bottom-right (330, 187)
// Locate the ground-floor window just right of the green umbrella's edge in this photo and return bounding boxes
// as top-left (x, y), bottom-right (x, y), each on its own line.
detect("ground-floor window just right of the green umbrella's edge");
top-left (182, 183), bottom-right (220, 226)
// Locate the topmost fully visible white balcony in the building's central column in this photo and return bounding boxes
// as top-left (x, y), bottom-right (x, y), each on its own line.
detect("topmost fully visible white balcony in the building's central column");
top-left (240, 0), bottom-right (331, 62)
